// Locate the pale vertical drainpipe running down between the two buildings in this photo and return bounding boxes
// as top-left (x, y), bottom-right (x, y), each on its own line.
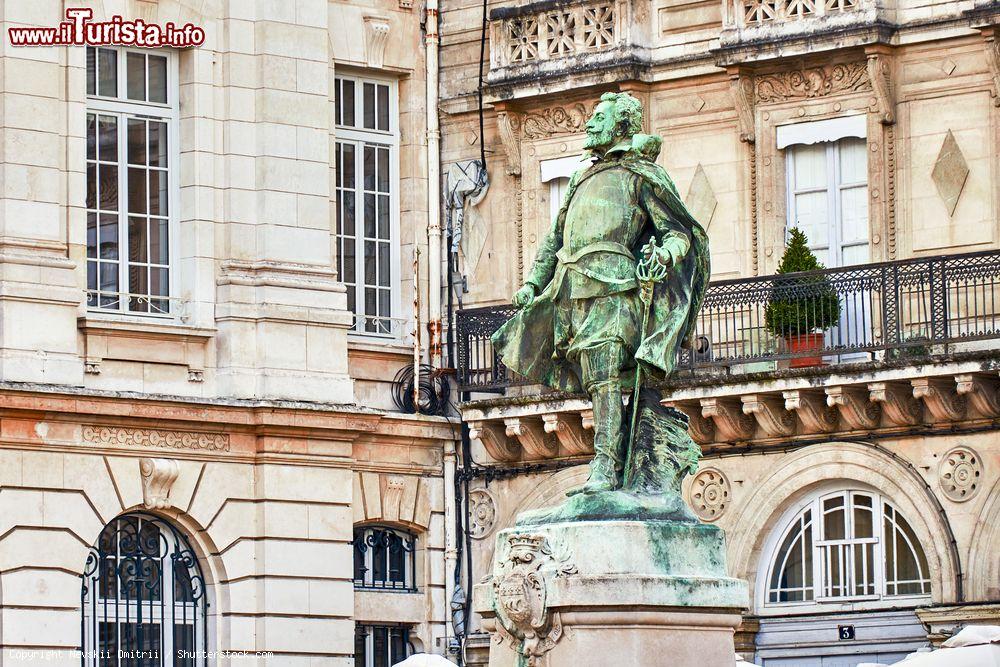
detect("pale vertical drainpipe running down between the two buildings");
top-left (424, 0), bottom-right (441, 368)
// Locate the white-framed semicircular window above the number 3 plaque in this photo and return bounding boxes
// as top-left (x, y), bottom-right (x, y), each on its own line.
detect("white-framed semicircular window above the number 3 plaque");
top-left (765, 491), bottom-right (931, 605)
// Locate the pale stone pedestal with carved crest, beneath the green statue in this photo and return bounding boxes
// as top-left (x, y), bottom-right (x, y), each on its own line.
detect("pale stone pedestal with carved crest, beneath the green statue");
top-left (474, 520), bottom-right (748, 667)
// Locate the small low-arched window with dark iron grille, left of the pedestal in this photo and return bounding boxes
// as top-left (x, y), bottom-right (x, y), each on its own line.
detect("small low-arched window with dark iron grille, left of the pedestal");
top-left (351, 526), bottom-right (417, 591)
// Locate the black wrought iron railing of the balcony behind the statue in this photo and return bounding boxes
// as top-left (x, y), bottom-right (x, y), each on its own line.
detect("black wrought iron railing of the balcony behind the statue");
top-left (456, 251), bottom-right (1000, 392)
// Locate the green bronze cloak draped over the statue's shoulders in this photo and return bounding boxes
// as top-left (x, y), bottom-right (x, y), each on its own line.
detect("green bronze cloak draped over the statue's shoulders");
top-left (492, 144), bottom-right (710, 393)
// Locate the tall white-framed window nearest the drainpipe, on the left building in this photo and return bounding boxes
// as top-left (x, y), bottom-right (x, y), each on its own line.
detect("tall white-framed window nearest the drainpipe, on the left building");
top-left (334, 76), bottom-right (400, 337)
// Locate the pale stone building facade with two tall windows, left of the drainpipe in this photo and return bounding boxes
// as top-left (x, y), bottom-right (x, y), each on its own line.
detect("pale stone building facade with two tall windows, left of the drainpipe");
top-left (0, 0), bottom-right (457, 667)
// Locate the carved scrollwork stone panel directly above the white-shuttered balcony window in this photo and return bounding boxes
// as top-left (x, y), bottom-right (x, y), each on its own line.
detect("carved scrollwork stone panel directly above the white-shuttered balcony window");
top-left (754, 62), bottom-right (872, 103)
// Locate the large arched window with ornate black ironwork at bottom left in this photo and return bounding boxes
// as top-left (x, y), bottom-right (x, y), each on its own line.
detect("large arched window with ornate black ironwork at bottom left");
top-left (81, 514), bottom-right (208, 667)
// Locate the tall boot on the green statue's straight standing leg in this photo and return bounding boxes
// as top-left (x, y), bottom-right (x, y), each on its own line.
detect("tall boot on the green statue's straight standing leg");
top-left (567, 380), bottom-right (625, 495)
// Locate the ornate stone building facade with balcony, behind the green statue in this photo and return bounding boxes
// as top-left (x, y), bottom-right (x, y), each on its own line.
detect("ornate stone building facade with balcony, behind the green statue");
top-left (441, 0), bottom-right (1000, 666)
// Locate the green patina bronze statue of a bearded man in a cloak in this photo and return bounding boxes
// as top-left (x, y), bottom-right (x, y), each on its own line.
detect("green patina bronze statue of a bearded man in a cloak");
top-left (493, 93), bottom-right (709, 524)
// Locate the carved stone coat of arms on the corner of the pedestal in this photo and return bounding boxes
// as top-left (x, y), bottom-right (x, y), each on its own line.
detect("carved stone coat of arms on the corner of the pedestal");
top-left (493, 535), bottom-right (576, 667)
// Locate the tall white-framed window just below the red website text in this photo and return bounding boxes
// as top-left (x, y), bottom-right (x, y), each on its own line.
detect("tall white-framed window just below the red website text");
top-left (86, 47), bottom-right (178, 316)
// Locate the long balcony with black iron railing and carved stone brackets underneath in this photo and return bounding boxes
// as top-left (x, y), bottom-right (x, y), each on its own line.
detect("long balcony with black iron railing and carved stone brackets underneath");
top-left (457, 251), bottom-right (1000, 462)
